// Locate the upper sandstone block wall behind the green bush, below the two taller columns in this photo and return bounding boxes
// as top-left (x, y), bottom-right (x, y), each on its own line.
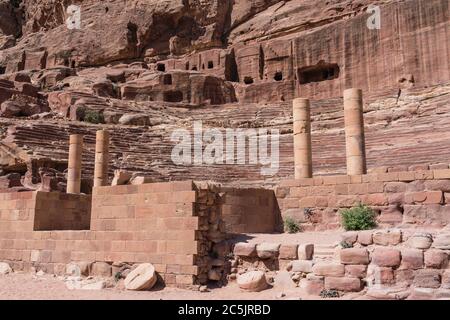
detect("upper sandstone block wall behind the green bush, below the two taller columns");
top-left (276, 169), bottom-right (450, 230)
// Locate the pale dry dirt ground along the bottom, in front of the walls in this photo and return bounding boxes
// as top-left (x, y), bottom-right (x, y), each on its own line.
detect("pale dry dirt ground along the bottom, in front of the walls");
top-left (0, 273), bottom-right (348, 300)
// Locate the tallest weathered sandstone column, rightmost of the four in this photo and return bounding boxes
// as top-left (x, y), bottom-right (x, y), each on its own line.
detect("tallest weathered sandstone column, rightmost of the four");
top-left (344, 89), bottom-right (367, 175)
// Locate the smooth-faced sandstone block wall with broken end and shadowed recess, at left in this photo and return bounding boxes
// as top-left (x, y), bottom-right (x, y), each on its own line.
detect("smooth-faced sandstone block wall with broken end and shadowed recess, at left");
top-left (0, 181), bottom-right (275, 287)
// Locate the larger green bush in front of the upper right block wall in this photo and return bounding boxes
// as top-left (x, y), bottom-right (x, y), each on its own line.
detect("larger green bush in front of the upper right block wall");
top-left (341, 204), bottom-right (377, 231)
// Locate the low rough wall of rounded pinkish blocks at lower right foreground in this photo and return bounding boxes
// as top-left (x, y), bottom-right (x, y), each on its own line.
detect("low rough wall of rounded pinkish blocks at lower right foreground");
top-left (229, 229), bottom-right (450, 299)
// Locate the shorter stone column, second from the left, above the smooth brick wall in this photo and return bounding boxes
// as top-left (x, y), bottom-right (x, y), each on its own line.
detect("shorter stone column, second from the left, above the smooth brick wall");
top-left (94, 130), bottom-right (109, 187)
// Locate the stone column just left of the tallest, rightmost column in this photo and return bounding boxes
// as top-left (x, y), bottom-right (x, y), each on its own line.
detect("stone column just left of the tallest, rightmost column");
top-left (293, 98), bottom-right (312, 179)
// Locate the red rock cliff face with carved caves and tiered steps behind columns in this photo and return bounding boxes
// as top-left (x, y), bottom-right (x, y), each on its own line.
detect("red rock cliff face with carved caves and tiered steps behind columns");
top-left (0, 0), bottom-right (450, 190)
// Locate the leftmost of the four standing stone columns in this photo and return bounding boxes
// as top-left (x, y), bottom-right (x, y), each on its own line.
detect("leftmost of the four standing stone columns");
top-left (67, 134), bottom-right (83, 193)
